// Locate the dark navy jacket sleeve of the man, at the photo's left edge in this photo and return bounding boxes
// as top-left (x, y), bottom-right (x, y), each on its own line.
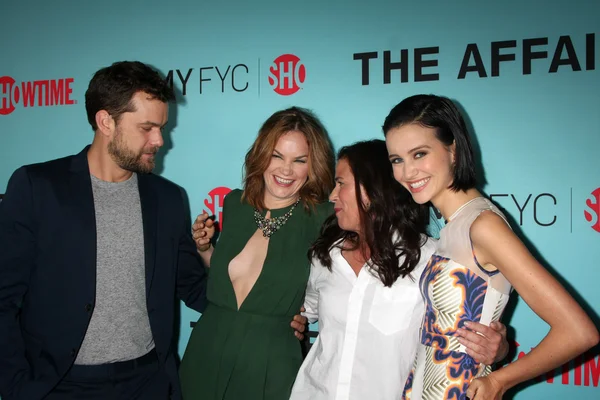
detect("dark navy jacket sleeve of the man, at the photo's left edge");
top-left (0, 167), bottom-right (36, 399)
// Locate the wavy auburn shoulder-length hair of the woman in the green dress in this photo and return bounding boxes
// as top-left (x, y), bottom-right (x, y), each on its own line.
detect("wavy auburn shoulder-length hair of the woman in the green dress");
top-left (242, 107), bottom-right (334, 210)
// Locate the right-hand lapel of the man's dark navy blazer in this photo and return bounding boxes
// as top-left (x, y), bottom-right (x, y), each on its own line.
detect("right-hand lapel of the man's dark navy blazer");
top-left (138, 174), bottom-right (158, 296)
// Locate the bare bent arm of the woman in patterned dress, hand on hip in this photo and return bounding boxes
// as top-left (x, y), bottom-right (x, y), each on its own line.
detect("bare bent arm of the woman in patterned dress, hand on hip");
top-left (467, 212), bottom-right (599, 400)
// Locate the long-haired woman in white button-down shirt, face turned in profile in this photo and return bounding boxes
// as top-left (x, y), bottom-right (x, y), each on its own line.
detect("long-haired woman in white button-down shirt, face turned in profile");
top-left (290, 140), bottom-right (506, 400)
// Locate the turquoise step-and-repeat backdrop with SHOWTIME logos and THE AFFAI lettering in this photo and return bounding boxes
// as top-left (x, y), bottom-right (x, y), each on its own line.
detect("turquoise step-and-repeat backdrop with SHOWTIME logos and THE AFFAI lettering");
top-left (0, 0), bottom-right (600, 400)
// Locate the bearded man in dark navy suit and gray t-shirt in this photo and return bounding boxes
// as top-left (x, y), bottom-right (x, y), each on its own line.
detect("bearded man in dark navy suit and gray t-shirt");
top-left (0, 62), bottom-right (206, 400)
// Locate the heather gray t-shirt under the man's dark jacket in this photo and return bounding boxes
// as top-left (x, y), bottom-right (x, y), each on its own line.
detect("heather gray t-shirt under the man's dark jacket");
top-left (75, 174), bottom-right (154, 365)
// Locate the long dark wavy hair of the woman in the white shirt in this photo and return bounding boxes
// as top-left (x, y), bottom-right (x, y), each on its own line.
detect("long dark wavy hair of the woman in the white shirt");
top-left (309, 140), bottom-right (429, 286)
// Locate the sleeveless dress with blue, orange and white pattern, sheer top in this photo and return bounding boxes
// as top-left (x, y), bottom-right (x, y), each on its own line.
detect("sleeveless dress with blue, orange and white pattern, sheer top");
top-left (402, 197), bottom-right (511, 400)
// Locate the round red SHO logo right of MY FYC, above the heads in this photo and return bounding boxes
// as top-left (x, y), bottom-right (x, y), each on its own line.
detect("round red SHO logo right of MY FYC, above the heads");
top-left (269, 54), bottom-right (306, 96)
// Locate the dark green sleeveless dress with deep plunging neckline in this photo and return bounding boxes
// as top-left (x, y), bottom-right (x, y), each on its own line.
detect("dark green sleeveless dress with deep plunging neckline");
top-left (180, 190), bottom-right (332, 400)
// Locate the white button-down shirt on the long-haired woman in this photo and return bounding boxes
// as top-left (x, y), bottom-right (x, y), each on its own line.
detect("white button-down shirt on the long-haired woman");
top-left (290, 239), bottom-right (435, 400)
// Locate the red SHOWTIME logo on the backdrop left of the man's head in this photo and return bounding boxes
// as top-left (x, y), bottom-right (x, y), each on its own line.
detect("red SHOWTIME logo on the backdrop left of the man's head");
top-left (0, 76), bottom-right (76, 115)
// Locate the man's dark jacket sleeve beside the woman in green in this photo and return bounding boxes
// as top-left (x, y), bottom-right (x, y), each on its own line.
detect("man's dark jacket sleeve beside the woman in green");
top-left (177, 187), bottom-right (208, 312)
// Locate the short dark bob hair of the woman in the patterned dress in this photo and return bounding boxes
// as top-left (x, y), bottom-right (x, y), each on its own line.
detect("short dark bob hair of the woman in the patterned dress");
top-left (383, 94), bottom-right (477, 192)
